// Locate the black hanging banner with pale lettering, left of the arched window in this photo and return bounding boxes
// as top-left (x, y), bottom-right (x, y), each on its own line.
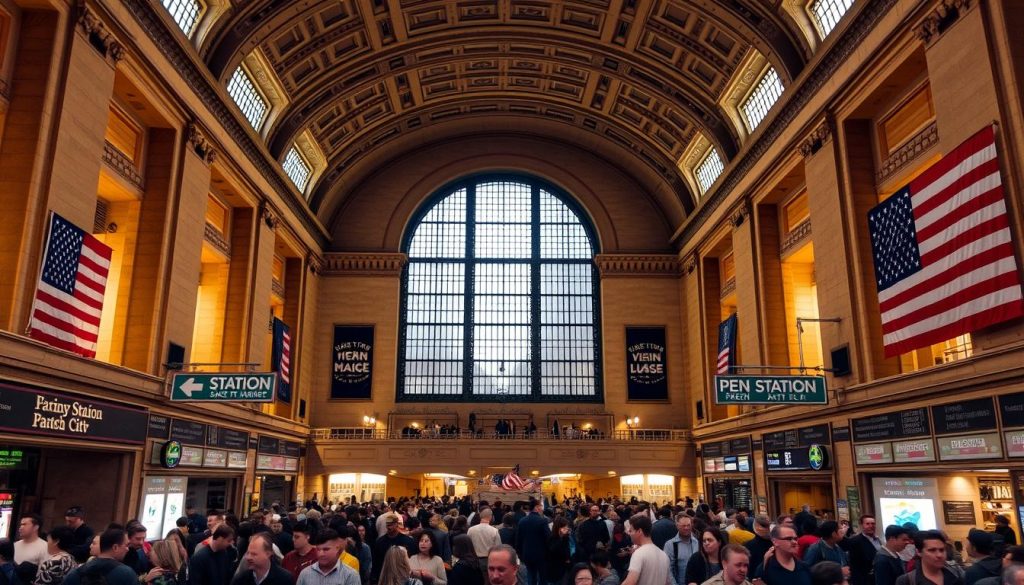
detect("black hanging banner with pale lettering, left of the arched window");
top-left (331, 325), bottom-right (374, 399)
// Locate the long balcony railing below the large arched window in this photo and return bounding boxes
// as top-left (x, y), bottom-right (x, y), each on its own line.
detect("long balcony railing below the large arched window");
top-left (311, 426), bottom-right (691, 442)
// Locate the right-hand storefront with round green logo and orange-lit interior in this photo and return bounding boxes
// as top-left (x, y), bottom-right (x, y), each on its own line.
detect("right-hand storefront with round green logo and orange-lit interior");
top-left (761, 424), bottom-right (837, 519)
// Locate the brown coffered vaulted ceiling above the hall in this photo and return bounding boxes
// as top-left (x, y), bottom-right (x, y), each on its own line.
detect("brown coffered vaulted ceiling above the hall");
top-left (200, 0), bottom-right (810, 225)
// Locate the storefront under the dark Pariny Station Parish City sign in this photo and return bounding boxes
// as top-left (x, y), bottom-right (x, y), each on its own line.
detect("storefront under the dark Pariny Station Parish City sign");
top-left (0, 380), bottom-right (146, 538)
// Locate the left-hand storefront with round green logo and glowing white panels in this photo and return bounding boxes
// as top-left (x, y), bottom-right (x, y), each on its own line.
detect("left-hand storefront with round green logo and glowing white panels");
top-left (139, 414), bottom-right (249, 524)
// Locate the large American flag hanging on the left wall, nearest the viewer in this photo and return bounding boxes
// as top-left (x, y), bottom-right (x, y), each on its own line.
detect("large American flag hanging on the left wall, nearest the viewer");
top-left (29, 212), bottom-right (111, 358)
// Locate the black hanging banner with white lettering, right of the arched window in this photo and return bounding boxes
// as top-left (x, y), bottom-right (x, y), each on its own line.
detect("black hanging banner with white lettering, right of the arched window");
top-left (626, 327), bottom-right (669, 401)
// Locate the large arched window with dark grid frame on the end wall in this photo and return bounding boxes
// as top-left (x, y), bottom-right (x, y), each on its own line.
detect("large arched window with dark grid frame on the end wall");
top-left (397, 176), bottom-right (601, 402)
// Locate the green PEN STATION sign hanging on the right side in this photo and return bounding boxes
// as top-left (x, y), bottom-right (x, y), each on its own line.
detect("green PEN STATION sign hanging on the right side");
top-left (715, 376), bottom-right (828, 405)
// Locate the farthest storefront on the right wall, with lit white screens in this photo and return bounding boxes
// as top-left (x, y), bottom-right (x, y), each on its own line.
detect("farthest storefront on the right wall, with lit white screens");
top-left (700, 436), bottom-right (754, 510)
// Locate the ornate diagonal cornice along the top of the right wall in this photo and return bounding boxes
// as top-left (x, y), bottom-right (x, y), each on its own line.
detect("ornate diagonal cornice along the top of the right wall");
top-left (679, 0), bottom-right (896, 244)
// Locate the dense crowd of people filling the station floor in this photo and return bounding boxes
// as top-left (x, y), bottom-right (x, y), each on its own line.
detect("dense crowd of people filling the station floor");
top-left (0, 496), bottom-right (1024, 585)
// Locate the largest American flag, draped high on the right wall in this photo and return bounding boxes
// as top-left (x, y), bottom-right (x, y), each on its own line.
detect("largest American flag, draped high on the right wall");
top-left (867, 126), bottom-right (1024, 357)
